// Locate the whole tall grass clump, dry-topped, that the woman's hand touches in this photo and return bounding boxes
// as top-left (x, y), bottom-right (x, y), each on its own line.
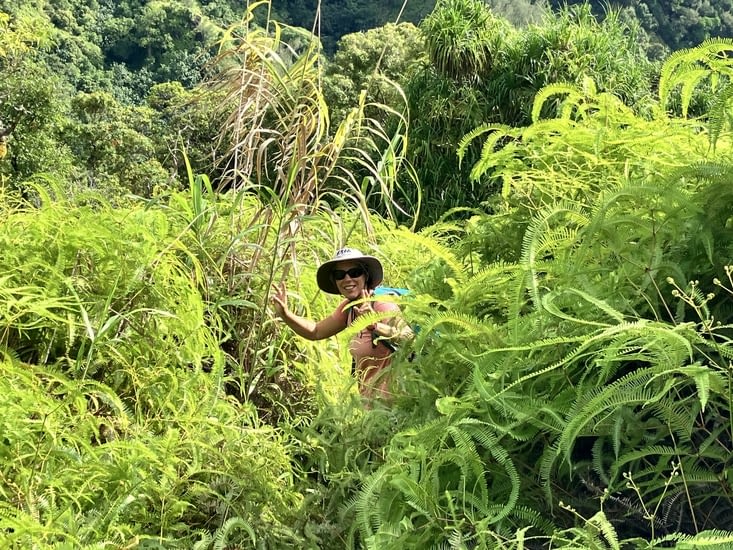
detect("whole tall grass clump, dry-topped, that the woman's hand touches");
top-left (187, 2), bottom-right (418, 413)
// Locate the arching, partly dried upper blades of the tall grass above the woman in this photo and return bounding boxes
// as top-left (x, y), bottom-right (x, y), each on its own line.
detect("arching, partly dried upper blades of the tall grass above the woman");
top-left (208, 4), bottom-right (419, 226)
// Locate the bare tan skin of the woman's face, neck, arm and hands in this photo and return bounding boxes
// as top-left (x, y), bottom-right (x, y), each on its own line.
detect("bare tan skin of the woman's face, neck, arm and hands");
top-left (271, 260), bottom-right (394, 340)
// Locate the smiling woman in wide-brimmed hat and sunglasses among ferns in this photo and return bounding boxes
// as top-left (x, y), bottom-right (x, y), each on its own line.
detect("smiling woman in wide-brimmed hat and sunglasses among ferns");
top-left (272, 248), bottom-right (410, 398)
